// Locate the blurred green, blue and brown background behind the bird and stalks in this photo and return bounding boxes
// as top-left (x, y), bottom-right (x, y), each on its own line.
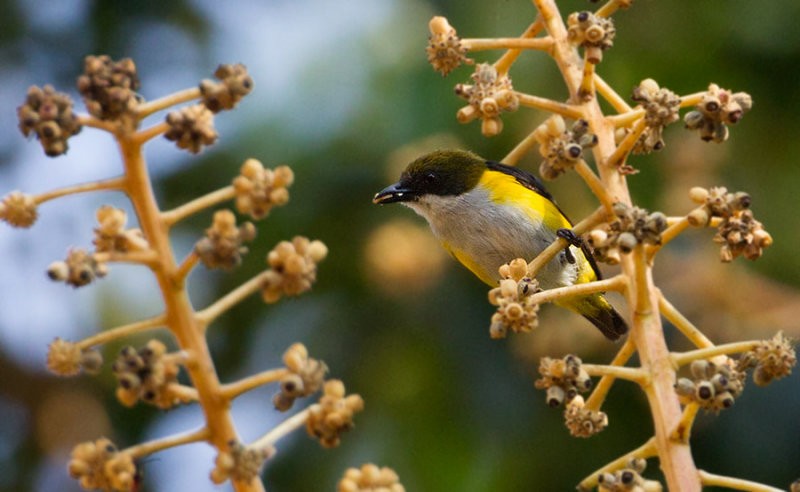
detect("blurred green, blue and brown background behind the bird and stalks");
top-left (0, 0), bottom-right (800, 492)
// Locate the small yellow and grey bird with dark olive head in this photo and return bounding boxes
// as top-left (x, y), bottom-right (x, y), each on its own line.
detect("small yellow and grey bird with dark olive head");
top-left (372, 150), bottom-right (628, 340)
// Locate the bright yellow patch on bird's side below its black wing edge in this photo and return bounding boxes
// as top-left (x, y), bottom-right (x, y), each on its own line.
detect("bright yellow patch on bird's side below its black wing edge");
top-left (480, 170), bottom-right (572, 230)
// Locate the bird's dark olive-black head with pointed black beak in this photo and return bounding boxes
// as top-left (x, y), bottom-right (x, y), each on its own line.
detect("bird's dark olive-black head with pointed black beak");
top-left (372, 150), bottom-right (486, 204)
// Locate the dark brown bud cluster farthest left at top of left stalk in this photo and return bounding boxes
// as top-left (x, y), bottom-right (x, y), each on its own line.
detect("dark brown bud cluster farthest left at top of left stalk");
top-left (17, 85), bottom-right (81, 157)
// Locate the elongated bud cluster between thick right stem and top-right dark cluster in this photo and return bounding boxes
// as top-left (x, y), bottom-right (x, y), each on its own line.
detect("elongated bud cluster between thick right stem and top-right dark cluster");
top-left (632, 79), bottom-right (681, 154)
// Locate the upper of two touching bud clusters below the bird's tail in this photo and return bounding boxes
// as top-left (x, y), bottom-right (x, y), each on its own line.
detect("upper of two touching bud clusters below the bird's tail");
top-left (534, 354), bottom-right (592, 407)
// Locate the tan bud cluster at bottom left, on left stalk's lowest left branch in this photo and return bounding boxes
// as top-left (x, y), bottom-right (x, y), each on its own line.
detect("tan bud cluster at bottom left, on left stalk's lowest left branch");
top-left (67, 437), bottom-right (136, 492)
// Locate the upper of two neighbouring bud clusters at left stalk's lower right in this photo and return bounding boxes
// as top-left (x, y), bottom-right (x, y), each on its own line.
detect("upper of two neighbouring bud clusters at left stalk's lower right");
top-left (272, 343), bottom-right (328, 412)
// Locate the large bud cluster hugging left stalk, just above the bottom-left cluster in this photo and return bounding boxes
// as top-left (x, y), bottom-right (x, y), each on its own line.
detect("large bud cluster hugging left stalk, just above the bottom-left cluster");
top-left (112, 340), bottom-right (188, 409)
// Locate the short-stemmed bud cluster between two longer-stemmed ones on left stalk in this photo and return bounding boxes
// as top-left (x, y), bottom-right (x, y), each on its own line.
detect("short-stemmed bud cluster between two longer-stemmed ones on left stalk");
top-left (194, 210), bottom-right (256, 270)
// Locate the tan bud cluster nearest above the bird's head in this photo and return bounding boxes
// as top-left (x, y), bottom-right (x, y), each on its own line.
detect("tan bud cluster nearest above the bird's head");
top-left (455, 63), bottom-right (519, 137)
